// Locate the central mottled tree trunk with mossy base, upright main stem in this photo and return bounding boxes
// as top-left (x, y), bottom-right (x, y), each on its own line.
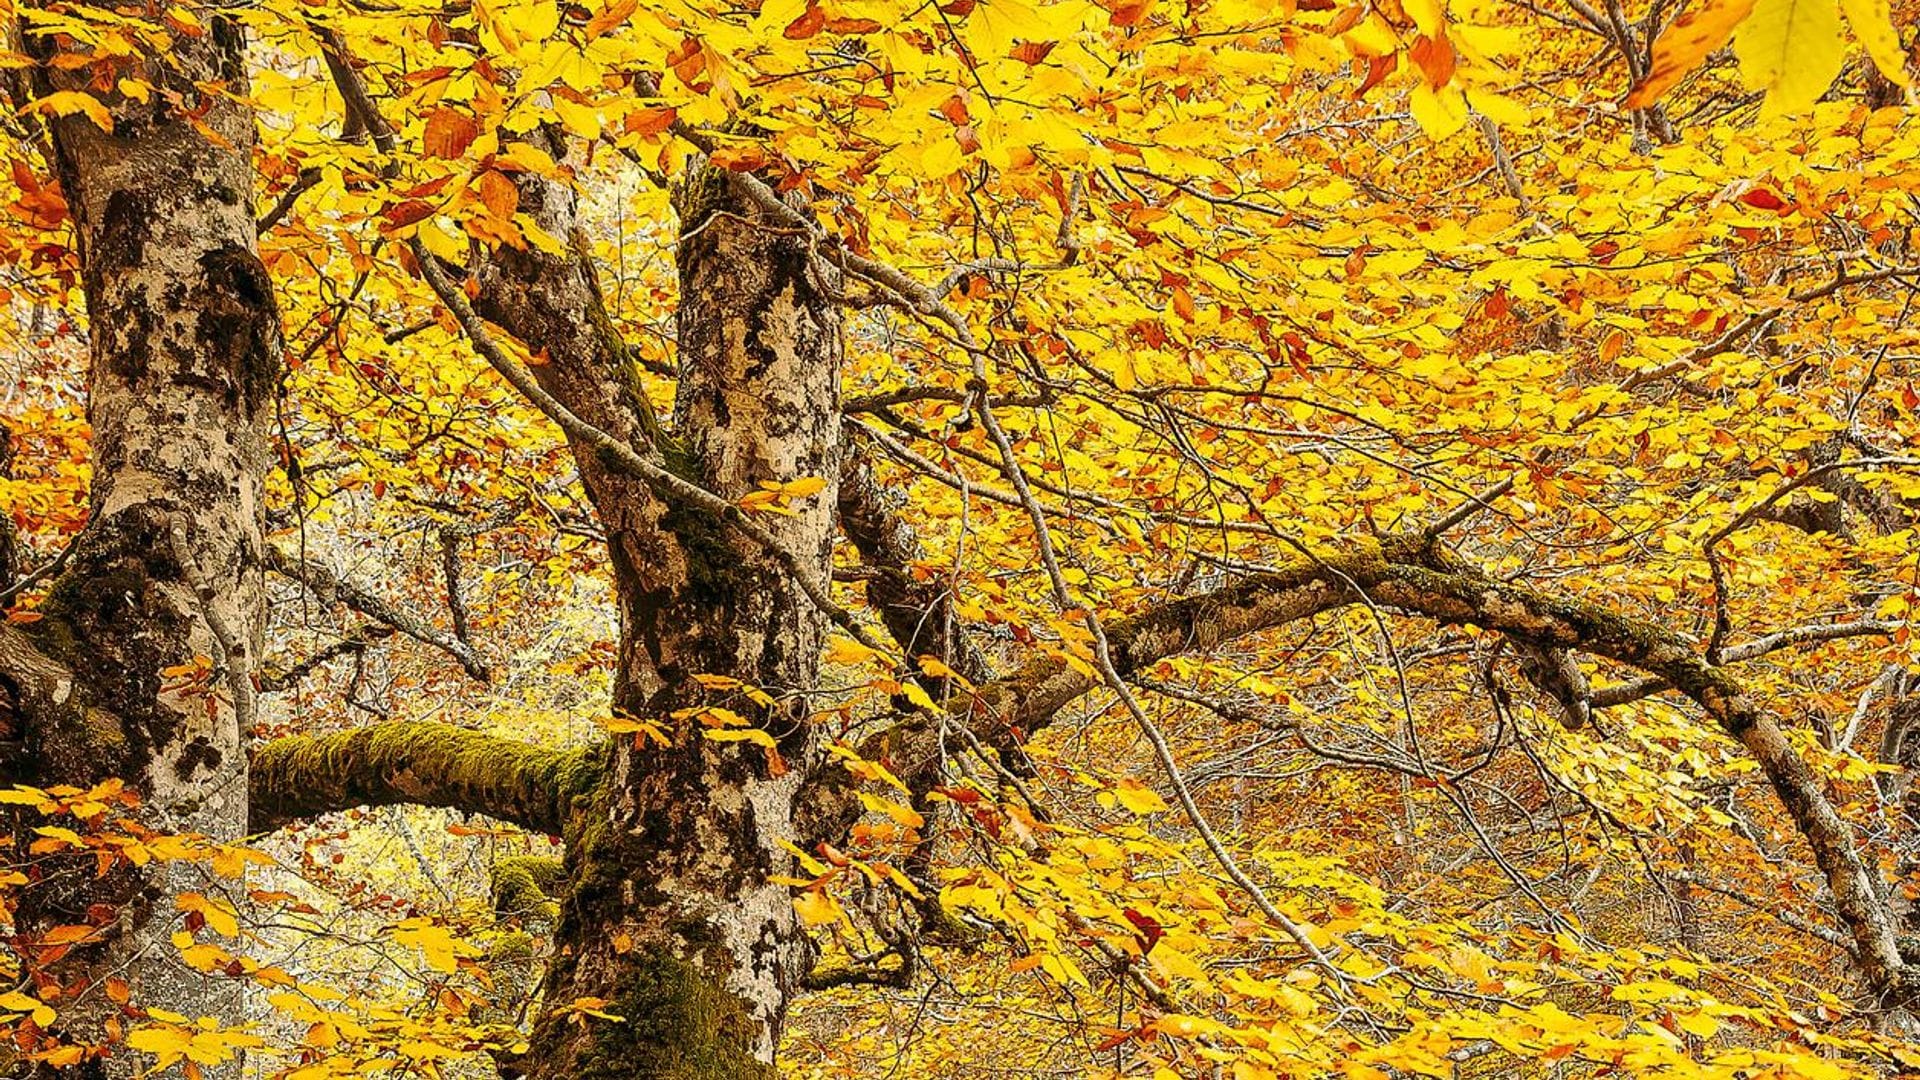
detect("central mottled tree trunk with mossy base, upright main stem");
top-left (506, 171), bottom-right (841, 1080)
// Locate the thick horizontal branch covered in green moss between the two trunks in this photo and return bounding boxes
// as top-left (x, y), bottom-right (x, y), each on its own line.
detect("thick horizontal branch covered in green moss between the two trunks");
top-left (248, 723), bottom-right (601, 836)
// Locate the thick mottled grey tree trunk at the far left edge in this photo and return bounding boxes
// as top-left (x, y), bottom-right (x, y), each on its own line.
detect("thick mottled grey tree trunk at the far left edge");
top-left (0, 12), bottom-right (280, 1074)
